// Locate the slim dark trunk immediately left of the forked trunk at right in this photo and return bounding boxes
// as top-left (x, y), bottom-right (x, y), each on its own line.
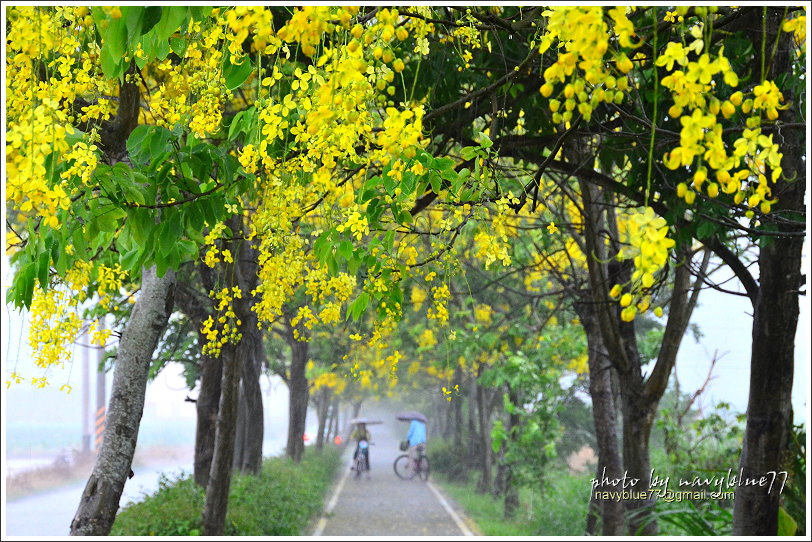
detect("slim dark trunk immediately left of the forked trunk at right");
top-left (575, 301), bottom-right (625, 536)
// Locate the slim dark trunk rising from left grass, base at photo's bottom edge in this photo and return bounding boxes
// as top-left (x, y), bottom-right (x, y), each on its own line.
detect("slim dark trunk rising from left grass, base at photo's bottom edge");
top-left (203, 344), bottom-right (241, 536)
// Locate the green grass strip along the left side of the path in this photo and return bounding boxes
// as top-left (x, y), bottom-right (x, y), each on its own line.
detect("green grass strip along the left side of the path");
top-left (110, 448), bottom-right (340, 536)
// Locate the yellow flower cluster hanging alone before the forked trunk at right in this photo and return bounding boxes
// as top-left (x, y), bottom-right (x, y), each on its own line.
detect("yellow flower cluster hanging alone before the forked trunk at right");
top-left (610, 207), bottom-right (675, 322)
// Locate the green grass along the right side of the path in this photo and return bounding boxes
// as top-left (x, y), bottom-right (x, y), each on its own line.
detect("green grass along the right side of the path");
top-left (435, 468), bottom-right (592, 536)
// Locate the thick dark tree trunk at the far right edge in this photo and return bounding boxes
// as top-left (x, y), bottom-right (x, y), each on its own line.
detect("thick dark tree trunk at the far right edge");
top-left (733, 8), bottom-right (808, 536)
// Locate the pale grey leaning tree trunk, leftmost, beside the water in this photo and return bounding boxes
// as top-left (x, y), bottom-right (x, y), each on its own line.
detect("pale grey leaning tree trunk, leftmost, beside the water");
top-left (70, 266), bottom-right (175, 536)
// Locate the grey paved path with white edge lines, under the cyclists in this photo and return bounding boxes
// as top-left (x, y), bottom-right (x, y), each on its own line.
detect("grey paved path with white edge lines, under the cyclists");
top-left (313, 415), bottom-right (474, 536)
